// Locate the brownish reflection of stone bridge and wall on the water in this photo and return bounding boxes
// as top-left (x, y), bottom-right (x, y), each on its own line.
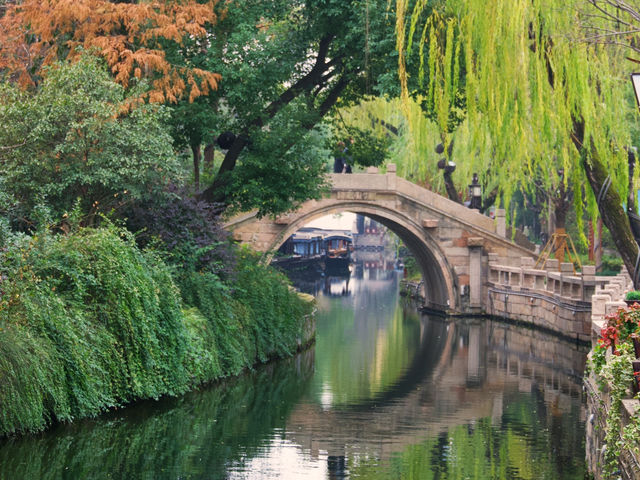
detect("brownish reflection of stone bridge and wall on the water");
top-left (286, 320), bottom-right (585, 468)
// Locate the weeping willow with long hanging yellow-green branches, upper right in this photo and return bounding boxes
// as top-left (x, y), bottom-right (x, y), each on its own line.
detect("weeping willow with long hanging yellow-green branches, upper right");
top-left (396, 0), bottom-right (638, 275)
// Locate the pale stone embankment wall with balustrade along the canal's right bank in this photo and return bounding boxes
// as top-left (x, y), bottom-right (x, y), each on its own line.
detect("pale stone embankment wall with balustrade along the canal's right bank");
top-left (484, 260), bottom-right (640, 480)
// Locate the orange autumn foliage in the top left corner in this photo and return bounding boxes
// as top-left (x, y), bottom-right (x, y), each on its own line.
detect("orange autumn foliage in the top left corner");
top-left (0, 0), bottom-right (220, 103)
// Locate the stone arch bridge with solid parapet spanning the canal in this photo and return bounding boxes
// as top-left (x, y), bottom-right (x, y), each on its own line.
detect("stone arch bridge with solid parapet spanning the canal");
top-left (225, 165), bottom-right (534, 312)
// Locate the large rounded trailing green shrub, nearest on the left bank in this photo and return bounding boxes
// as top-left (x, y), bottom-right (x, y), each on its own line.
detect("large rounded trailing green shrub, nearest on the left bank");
top-left (0, 227), bottom-right (189, 433)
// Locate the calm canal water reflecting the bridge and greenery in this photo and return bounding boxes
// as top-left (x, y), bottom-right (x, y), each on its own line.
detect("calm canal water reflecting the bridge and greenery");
top-left (0, 263), bottom-right (586, 480)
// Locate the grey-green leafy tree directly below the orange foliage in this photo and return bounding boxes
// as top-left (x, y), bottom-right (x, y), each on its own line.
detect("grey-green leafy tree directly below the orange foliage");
top-left (0, 56), bottom-right (178, 225)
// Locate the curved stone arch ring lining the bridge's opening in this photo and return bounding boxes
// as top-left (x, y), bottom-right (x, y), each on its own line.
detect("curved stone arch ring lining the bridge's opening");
top-left (268, 201), bottom-right (459, 310)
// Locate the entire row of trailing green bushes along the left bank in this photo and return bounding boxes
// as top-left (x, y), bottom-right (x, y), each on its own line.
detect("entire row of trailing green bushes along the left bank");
top-left (0, 226), bottom-right (308, 434)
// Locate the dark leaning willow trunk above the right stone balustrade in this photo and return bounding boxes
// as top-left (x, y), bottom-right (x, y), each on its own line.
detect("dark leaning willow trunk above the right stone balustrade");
top-left (572, 118), bottom-right (639, 288)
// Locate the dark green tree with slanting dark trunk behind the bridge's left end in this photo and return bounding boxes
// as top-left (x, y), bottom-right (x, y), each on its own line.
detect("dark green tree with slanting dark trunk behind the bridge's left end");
top-left (160, 0), bottom-right (395, 214)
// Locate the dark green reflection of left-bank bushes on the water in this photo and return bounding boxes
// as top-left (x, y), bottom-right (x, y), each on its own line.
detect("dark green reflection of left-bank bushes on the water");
top-left (0, 351), bottom-right (314, 480)
